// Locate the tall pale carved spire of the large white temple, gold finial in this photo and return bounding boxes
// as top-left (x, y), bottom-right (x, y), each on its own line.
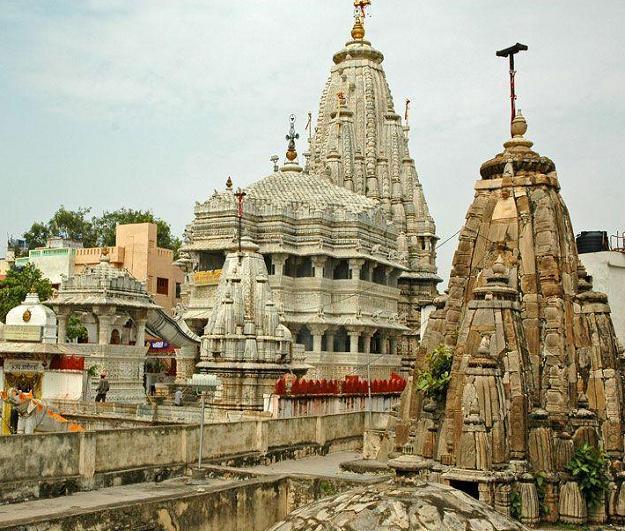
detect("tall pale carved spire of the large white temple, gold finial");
top-left (305, 6), bottom-right (441, 356)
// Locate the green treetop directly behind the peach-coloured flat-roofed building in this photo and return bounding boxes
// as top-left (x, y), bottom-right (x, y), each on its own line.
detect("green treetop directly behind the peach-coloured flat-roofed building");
top-left (93, 208), bottom-right (181, 253)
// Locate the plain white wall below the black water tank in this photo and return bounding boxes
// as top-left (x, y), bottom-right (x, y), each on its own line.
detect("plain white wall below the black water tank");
top-left (579, 251), bottom-right (625, 345)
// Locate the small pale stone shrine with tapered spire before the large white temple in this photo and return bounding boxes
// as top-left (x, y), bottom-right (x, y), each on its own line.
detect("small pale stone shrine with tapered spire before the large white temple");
top-left (196, 237), bottom-right (309, 411)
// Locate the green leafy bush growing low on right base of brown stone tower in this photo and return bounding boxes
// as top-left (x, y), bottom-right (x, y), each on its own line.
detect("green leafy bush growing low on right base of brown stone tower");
top-left (566, 443), bottom-right (610, 508)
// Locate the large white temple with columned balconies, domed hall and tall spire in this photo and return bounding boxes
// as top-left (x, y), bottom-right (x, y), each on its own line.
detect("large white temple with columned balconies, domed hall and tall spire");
top-left (179, 1), bottom-right (440, 378)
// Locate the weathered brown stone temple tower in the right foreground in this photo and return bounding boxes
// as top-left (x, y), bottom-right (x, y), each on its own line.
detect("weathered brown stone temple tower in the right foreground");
top-left (392, 113), bottom-right (625, 524)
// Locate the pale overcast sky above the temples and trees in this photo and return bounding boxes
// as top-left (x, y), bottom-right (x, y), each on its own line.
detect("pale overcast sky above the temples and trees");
top-left (0, 0), bottom-right (625, 286)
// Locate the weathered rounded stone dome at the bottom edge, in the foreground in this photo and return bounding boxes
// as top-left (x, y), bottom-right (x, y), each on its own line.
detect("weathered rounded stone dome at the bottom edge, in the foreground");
top-left (271, 482), bottom-right (527, 531)
